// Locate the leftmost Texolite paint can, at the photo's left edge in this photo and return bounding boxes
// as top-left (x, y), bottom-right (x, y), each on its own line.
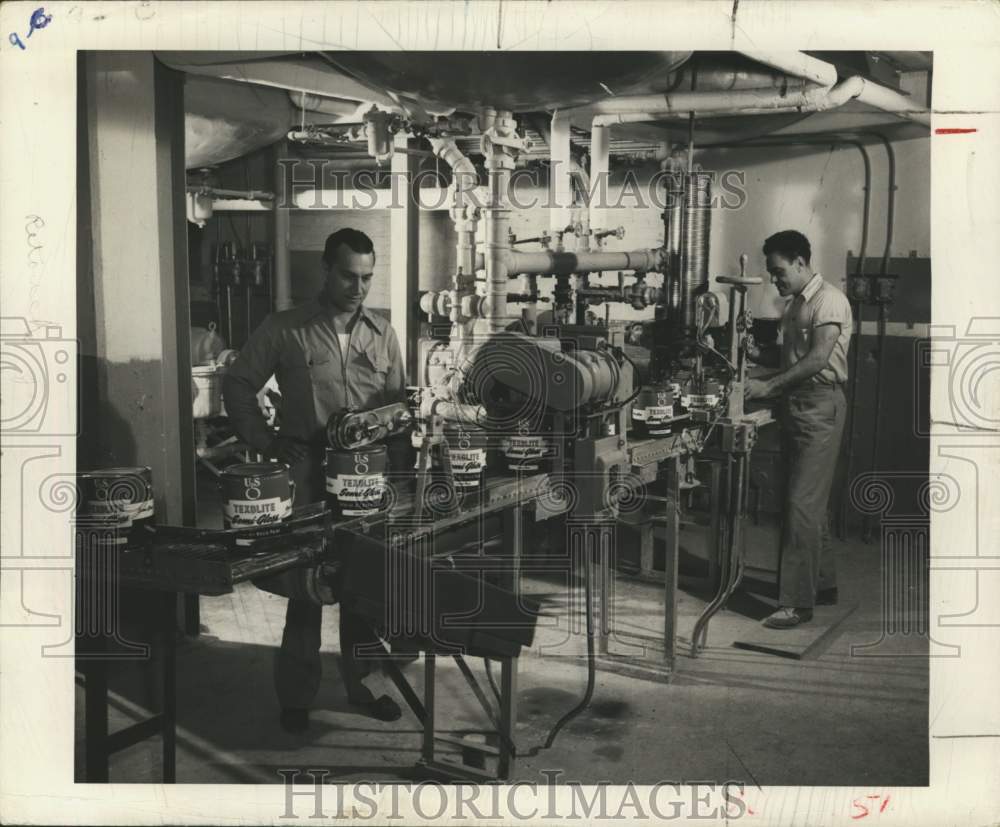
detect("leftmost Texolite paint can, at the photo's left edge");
top-left (77, 466), bottom-right (154, 550)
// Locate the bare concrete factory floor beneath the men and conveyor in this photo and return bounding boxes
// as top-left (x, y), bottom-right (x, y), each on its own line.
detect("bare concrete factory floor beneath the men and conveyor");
top-left (78, 512), bottom-right (928, 786)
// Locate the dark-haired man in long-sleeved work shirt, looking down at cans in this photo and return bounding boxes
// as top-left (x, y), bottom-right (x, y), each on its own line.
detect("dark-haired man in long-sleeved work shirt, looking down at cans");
top-left (222, 228), bottom-right (406, 731)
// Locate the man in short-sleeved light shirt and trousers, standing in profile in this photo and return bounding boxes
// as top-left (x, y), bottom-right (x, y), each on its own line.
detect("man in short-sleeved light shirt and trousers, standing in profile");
top-left (746, 230), bottom-right (854, 629)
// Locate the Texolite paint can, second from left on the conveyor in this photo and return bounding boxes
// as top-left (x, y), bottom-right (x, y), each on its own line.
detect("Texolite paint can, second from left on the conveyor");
top-left (220, 462), bottom-right (294, 546)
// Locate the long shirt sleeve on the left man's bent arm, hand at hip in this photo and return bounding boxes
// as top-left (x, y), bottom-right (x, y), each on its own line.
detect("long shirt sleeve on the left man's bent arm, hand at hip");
top-left (222, 317), bottom-right (281, 453)
